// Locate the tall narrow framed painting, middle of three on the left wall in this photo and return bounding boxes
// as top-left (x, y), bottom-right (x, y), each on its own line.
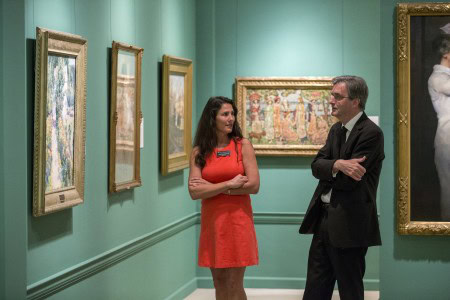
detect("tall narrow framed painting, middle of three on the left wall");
top-left (108, 41), bottom-right (144, 193)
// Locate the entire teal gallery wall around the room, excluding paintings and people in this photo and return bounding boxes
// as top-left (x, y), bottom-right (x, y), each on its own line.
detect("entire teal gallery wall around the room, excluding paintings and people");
top-left (6, 0), bottom-right (450, 300)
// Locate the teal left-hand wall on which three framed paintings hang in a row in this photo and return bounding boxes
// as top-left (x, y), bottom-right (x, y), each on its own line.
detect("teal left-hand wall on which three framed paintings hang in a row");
top-left (0, 0), bottom-right (198, 299)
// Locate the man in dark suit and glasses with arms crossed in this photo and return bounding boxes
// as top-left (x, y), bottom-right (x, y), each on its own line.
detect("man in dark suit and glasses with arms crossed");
top-left (299, 76), bottom-right (384, 300)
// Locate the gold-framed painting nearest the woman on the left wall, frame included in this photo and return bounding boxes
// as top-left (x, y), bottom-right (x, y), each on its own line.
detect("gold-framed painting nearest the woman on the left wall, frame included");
top-left (161, 55), bottom-right (192, 175)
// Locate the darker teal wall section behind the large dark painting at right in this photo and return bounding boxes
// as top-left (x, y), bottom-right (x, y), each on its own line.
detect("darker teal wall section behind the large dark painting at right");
top-left (380, 0), bottom-right (450, 300)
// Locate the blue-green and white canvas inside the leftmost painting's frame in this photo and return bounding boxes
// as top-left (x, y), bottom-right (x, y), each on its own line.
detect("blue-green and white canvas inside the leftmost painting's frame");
top-left (45, 55), bottom-right (76, 193)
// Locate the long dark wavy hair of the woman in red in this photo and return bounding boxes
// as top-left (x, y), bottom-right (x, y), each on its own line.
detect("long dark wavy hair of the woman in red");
top-left (194, 96), bottom-right (242, 169)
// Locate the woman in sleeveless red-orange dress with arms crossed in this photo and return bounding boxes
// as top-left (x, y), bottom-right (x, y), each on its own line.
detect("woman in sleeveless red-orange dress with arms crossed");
top-left (189, 97), bottom-right (259, 300)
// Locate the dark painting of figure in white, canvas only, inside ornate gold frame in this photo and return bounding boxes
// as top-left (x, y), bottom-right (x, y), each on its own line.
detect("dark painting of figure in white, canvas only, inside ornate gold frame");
top-left (410, 16), bottom-right (450, 222)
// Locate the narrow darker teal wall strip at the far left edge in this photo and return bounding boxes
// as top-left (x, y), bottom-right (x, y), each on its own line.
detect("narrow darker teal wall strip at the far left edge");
top-left (0, 0), bottom-right (31, 299)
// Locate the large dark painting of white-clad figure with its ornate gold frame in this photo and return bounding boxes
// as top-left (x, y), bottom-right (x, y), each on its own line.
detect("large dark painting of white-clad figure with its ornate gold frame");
top-left (396, 3), bottom-right (450, 235)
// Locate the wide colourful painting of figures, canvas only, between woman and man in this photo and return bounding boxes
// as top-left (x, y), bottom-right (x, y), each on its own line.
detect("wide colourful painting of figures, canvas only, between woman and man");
top-left (242, 89), bottom-right (336, 145)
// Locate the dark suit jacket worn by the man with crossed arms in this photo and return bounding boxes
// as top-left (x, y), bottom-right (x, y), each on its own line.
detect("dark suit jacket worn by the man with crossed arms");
top-left (299, 113), bottom-right (384, 248)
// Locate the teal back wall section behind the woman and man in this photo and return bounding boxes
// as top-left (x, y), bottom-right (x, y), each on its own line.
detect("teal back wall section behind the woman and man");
top-left (197, 0), bottom-right (380, 289)
